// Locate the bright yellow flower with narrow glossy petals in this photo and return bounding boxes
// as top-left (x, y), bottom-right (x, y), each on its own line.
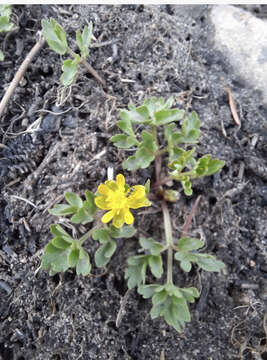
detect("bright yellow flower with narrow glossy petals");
top-left (95, 174), bottom-right (151, 229)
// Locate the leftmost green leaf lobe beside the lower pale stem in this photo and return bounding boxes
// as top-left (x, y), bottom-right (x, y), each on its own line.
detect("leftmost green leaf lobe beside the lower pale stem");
top-left (125, 255), bottom-right (149, 289)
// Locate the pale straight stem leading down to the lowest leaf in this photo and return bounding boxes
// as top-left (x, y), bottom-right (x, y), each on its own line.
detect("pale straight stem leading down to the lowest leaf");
top-left (161, 200), bottom-right (173, 284)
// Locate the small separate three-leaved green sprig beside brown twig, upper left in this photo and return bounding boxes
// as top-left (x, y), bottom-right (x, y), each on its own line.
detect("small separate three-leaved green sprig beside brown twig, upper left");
top-left (42, 19), bottom-right (98, 86)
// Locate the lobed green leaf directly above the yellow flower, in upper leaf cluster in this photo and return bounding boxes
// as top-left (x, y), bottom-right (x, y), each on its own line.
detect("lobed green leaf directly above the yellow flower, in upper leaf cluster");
top-left (122, 130), bottom-right (158, 171)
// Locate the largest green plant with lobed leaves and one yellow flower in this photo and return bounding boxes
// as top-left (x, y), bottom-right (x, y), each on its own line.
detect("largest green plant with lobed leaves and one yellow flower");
top-left (42, 98), bottom-right (224, 332)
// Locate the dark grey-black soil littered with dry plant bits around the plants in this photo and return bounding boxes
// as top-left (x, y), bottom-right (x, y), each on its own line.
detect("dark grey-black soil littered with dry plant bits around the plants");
top-left (0, 5), bottom-right (267, 360)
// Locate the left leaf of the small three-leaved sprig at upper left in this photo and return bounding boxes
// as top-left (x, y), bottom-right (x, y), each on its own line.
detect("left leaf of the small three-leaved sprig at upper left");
top-left (42, 18), bottom-right (68, 55)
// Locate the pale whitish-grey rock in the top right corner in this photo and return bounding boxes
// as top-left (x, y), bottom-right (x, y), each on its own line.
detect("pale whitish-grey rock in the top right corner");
top-left (211, 5), bottom-right (267, 102)
